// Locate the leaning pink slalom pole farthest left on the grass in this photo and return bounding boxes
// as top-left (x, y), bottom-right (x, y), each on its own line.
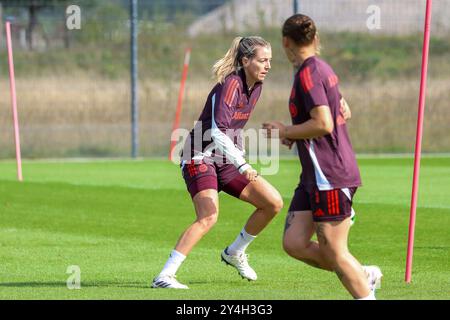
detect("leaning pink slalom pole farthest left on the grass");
top-left (6, 21), bottom-right (23, 181)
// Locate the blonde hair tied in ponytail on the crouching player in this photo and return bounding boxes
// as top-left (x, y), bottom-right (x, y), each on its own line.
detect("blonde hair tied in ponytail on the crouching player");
top-left (212, 36), bottom-right (270, 83)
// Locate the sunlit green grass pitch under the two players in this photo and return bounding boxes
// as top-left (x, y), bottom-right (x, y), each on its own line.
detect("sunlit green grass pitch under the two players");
top-left (0, 157), bottom-right (450, 300)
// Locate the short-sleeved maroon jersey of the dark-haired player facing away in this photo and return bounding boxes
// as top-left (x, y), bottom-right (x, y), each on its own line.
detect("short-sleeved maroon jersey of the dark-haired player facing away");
top-left (289, 56), bottom-right (361, 190)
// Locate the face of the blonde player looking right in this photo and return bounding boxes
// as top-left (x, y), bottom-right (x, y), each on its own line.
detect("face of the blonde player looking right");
top-left (242, 47), bottom-right (272, 83)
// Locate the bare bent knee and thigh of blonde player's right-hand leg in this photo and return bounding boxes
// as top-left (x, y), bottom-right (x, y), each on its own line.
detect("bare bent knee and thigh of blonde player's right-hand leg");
top-left (239, 176), bottom-right (282, 208)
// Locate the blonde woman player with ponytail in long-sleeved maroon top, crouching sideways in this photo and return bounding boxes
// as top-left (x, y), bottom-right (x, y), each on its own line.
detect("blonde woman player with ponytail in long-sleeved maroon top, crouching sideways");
top-left (152, 37), bottom-right (283, 289)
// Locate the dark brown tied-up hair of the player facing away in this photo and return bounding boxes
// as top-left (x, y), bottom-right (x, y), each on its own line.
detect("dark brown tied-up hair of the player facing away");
top-left (282, 14), bottom-right (317, 46)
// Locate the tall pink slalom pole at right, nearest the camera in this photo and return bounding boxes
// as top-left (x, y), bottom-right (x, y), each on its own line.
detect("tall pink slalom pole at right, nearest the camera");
top-left (405, 0), bottom-right (432, 283)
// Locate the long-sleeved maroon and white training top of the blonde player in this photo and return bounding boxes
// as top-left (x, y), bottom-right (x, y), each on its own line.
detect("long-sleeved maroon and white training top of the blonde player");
top-left (182, 69), bottom-right (262, 168)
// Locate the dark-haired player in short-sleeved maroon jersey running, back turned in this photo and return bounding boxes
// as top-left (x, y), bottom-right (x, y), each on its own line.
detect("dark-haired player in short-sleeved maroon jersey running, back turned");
top-left (263, 14), bottom-right (382, 300)
